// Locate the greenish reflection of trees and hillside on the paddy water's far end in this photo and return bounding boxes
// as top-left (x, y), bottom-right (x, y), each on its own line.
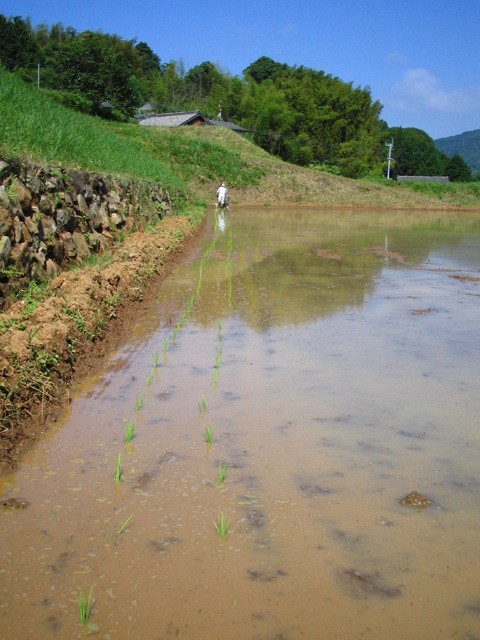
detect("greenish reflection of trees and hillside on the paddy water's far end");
top-left (160, 210), bottom-right (478, 331)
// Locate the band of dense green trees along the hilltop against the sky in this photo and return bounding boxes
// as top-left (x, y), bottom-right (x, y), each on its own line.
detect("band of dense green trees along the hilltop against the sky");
top-left (0, 15), bottom-right (471, 180)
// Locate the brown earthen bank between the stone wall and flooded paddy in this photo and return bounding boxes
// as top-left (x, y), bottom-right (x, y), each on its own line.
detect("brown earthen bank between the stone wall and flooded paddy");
top-left (0, 217), bottom-right (204, 474)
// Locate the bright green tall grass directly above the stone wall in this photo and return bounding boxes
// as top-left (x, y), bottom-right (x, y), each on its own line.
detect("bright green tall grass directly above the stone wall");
top-left (0, 69), bottom-right (186, 194)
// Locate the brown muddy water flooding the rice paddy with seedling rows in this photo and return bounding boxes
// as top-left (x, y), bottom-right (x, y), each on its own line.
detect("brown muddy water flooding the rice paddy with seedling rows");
top-left (0, 210), bottom-right (480, 640)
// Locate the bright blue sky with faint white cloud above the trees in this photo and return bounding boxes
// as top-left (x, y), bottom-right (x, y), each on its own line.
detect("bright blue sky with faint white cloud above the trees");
top-left (0, 0), bottom-right (480, 139)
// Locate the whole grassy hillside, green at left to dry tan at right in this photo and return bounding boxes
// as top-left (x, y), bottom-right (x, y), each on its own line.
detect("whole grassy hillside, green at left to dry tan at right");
top-left (0, 70), bottom-right (480, 208)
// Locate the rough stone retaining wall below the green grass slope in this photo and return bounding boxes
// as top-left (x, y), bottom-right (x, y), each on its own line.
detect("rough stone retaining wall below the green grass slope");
top-left (0, 160), bottom-right (172, 309)
